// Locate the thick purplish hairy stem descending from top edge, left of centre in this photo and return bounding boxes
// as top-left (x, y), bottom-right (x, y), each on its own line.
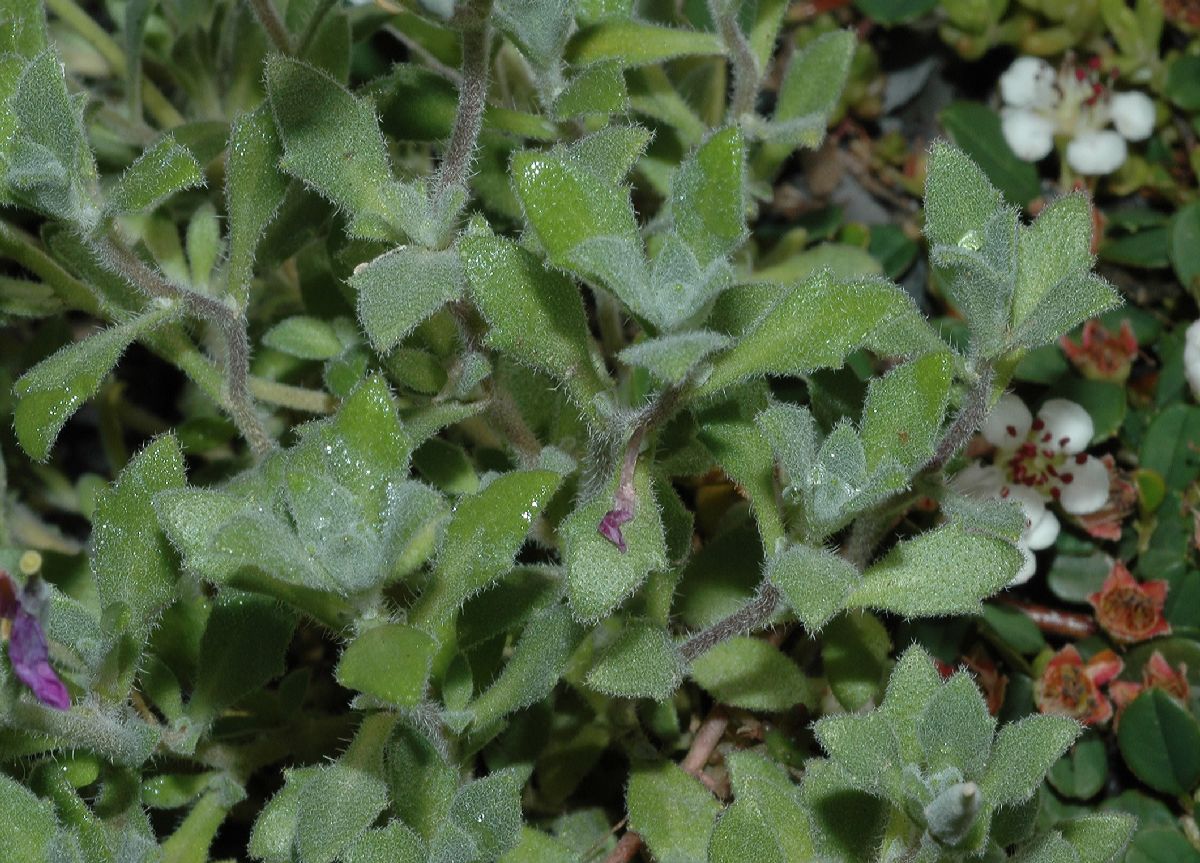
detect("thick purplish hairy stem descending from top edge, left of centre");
top-left (432, 0), bottom-right (491, 202)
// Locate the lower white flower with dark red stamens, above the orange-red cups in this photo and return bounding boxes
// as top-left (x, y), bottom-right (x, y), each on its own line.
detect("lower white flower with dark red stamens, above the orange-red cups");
top-left (954, 396), bottom-right (1108, 585)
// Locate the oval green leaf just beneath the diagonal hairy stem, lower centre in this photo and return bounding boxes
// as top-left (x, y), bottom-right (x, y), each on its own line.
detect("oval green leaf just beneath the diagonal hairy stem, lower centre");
top-left (691, 636), bottom-right (814, 711)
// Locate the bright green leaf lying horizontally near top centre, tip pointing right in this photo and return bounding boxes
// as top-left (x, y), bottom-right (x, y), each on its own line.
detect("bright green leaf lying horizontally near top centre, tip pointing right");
top-left (566, 18), bottom-right (725, 66)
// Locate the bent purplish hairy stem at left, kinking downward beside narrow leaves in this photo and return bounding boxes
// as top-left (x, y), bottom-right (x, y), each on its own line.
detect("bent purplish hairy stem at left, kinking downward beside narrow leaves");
top-left (90, 235), bottom-right (275, 457)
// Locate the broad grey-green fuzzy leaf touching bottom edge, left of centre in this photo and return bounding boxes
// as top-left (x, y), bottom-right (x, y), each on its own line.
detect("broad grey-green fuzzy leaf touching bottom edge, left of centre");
top-left (295, 763), bottom-right (388, 863)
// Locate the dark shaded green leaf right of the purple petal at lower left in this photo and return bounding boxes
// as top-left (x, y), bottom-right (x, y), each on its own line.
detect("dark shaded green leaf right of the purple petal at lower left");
top-left (187, 588), bottom-right (296, 721)
